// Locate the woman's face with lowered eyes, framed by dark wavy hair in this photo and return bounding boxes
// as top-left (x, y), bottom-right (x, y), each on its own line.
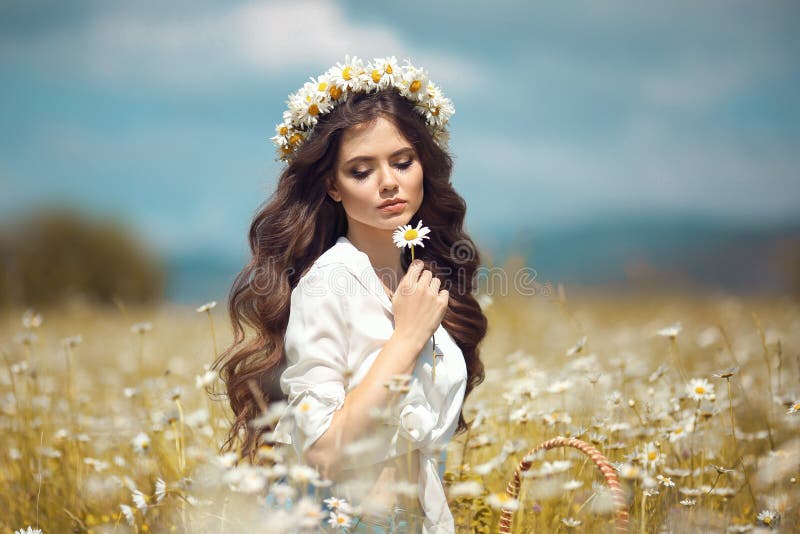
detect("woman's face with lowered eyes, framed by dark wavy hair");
top-left (328, 117), bottom-right (422, 231)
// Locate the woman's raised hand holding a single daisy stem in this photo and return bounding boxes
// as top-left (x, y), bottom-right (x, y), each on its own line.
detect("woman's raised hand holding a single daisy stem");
top-left (392, 260), bottom-right (450, 350)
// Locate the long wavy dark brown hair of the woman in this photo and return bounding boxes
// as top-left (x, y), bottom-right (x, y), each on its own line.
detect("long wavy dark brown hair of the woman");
top-left (213, 89), bottom-right (487, 461)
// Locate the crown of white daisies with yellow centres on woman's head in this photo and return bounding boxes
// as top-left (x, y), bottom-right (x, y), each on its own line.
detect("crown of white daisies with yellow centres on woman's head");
top-left (271, 55), bottom-right (455, 161)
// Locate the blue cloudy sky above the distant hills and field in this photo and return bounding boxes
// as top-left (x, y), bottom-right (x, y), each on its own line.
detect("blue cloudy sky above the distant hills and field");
top-left (0, 0), bottom-right (800, 260)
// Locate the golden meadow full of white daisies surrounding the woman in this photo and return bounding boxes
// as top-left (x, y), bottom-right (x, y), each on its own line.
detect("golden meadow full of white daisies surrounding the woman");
top-left (0, 292), bottom-right (800, 534)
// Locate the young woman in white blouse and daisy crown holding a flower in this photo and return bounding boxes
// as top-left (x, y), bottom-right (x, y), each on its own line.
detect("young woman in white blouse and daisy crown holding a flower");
top-left (216, 56), bottom-right (487, 532)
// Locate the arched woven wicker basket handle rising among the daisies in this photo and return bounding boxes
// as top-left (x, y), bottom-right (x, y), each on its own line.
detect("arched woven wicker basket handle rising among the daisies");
top-left (499, 437), bottom-right (628, 534)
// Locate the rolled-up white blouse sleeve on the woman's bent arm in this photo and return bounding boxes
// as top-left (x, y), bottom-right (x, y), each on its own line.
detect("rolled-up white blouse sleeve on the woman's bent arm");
top-left (276, 267), bottom-right (348, 458)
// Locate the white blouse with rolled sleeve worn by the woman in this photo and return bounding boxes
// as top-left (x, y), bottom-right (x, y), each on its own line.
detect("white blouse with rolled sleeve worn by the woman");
top-left (274, 236), bottom-right (467, 533)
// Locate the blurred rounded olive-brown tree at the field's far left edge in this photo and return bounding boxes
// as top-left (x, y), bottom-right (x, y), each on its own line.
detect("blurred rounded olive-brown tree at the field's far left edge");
top-left (0, 209), bottom-right (165, 307)
